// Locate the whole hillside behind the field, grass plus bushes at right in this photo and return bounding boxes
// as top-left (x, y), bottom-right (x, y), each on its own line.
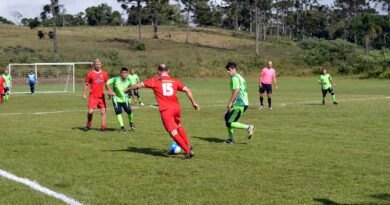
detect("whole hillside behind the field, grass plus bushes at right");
top-left (0, 25), bottom-right (390, 79)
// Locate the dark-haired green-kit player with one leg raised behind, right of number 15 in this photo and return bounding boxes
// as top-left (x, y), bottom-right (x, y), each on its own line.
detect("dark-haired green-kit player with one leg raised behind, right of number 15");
top-left (224, 62), bottom-right (255, 144)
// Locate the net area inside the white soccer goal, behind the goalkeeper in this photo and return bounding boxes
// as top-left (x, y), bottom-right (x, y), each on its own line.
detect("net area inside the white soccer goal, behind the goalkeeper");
top-left (8, 63), bottom-right (75, 93)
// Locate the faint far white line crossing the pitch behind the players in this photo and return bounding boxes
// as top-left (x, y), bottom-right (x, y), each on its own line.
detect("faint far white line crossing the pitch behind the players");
top-left (0, 96), bottom-right (390, 116)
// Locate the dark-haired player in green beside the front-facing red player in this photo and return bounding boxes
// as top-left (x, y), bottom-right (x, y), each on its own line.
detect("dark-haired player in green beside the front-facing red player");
top-left (107, 67), bottom-right (135, 132)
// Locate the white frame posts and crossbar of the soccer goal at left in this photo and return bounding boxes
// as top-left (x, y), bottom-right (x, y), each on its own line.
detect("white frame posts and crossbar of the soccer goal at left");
top-left (8, 62), bottom-right (93, 94)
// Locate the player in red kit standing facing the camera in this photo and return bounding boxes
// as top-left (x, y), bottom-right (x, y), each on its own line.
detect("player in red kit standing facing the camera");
top-left (83, 59), bottom-right (108, 131)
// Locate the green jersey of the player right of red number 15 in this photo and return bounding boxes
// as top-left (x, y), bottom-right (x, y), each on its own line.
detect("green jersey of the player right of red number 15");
top-left (230, 73), bottom-right (249, 106)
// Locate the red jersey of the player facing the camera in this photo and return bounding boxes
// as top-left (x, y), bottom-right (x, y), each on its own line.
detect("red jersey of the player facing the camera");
top-left (85, 70), bottom-right (108, 98)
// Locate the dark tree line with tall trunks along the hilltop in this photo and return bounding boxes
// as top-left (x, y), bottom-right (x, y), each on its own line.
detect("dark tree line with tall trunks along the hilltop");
top-left (0, 0), bottom-right (390, 54)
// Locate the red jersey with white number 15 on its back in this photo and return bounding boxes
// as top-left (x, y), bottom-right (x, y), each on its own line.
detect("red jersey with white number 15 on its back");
top-left (142, 76), bottom-right (185, 111)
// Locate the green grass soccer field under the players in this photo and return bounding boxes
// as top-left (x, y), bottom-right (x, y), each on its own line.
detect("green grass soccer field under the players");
top-left (0, 77), bottom-right (390, 205)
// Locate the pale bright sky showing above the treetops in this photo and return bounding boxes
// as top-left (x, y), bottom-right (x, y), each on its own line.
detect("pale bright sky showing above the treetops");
top-left (0, 0), bottom-right (333, 22)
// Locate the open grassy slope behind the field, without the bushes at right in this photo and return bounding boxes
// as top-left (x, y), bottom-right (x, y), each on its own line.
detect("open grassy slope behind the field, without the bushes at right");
top-left (0, 25), bottom-right (312, 78)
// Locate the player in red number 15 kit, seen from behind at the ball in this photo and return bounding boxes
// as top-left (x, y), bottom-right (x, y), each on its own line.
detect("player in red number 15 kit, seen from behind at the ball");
top-left (126, 64), bottom-right (200, 159)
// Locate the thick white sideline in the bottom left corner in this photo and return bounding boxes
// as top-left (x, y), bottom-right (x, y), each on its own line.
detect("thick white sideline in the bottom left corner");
top-left (0, 169), bottom-right (83, 205)
